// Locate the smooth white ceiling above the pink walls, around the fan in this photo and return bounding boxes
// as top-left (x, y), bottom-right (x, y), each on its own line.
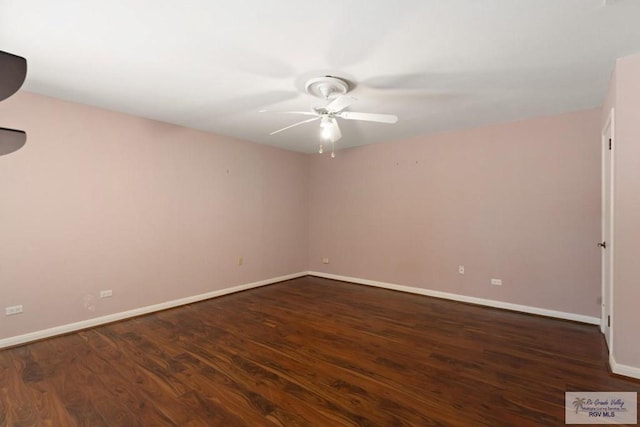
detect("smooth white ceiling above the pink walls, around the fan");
top-left (0, 0), bottom-right (640, 152)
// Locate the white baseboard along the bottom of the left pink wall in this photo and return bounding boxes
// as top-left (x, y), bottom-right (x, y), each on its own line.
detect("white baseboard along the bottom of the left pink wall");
top-left (0, 271), bottom-right (307, 348)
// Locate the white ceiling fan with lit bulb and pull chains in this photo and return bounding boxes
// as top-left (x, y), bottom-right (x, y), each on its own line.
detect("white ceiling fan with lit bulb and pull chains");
top-left (269, 76), bottom-right (398, 157)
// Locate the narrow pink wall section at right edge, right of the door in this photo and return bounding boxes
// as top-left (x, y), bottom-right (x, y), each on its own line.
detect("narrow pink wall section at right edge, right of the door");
top-left (612, 55), bottom-right (640, 372)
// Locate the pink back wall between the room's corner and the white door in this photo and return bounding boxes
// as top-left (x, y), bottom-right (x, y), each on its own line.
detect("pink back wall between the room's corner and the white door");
top-left (309, 109), bottom-right (600, 317)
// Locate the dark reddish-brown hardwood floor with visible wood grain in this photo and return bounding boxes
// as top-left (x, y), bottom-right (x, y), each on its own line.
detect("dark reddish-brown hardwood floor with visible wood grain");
top-left (0, 277), bottom-right (640, 426)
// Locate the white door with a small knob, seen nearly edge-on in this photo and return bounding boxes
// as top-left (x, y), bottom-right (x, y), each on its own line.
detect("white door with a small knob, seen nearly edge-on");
top-left (598, 108), bottom-right (615, 351)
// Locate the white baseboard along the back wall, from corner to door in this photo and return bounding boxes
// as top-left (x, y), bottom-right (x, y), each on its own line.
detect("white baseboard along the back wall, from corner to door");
top-left (308, 271), bottom-right (600, 325)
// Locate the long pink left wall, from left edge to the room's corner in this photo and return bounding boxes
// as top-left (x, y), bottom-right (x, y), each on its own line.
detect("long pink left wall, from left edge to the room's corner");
top-left (0, 92), bottom-right (308, 339)
